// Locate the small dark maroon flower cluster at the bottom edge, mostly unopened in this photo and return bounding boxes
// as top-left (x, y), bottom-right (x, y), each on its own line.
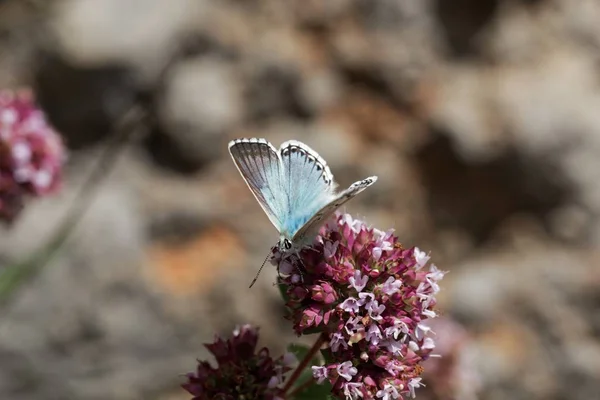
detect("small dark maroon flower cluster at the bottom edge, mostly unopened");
top-left (181, 325), bottom-right (295, 400)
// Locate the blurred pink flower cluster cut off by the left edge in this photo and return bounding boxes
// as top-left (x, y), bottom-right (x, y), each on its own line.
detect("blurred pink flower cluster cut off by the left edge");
top-left (0, 91), bottom-right (65, 222)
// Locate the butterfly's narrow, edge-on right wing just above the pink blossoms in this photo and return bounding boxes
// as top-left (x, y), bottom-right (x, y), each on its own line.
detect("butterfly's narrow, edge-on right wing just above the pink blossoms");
top-left (292, 176), bottom-right (377, 247)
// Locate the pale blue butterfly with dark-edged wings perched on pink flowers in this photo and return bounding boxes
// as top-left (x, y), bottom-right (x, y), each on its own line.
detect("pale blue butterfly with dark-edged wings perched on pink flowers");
top-left (229, 138), bottom-right (377, 278)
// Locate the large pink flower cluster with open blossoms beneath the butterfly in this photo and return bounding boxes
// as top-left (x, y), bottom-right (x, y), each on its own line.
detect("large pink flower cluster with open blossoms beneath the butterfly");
top-left (272, 214), bottom-right (444, 400)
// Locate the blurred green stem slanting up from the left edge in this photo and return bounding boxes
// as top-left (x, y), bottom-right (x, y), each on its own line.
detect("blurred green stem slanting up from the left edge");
top-left (0, 108), bottom-right (144, 306)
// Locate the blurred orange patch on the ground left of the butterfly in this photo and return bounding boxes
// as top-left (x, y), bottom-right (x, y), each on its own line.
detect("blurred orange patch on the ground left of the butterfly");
top-left (149, 226), bottom-right (245, 295)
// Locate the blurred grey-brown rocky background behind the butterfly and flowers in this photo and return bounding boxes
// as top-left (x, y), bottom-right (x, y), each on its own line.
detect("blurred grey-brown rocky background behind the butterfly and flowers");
top-left (0, 0), bottom-right (600, 400)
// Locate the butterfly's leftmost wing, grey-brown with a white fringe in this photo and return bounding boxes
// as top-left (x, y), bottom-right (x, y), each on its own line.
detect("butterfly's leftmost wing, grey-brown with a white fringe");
top-left (229, 139), bottom-right (288, 231)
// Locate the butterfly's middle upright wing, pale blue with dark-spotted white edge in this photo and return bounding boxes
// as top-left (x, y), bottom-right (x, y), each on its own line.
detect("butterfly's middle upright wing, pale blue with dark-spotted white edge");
top-left (279, 140), bottom-right (335, 239)
